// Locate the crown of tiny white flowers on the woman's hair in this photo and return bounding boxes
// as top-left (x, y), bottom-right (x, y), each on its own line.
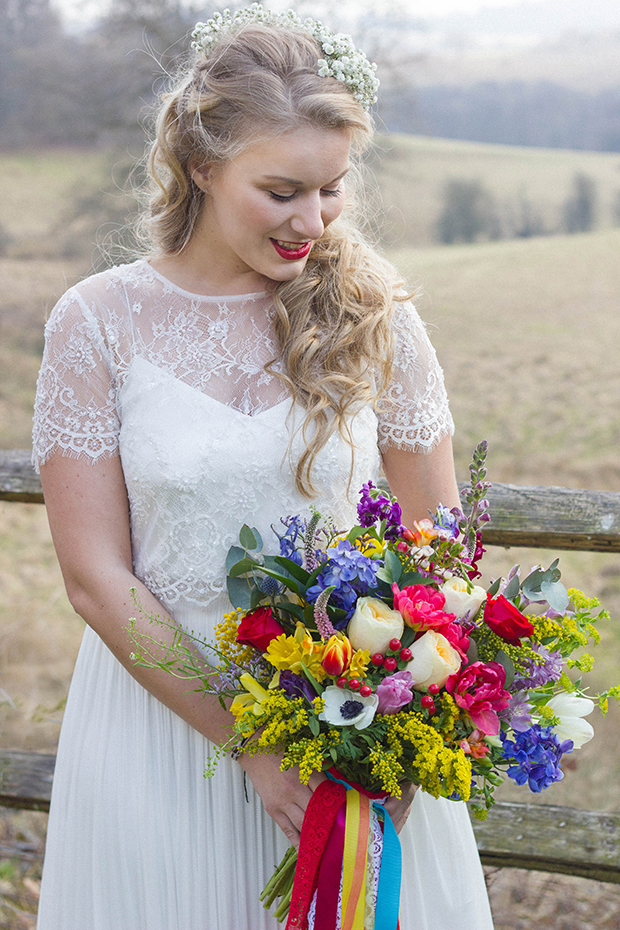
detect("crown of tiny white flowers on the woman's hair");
top-left (192, 3), bottom-right (379, 110)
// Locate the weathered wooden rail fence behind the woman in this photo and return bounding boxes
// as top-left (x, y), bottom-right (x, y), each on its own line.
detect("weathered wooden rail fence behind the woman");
top-left (0, 451), bottom-right (620, 884)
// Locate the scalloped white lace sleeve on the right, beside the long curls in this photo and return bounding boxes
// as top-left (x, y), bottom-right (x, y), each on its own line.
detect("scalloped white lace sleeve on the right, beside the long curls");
top-left (372, 303), bottom-right (454, 452)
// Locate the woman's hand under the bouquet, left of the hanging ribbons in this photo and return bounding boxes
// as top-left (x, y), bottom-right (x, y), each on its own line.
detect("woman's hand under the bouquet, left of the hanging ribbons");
top-left (239, 753), bottom-right (326, 847)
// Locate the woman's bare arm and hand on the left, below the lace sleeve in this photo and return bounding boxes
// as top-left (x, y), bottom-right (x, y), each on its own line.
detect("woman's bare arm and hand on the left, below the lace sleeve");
top-left (41, 455), bottom-right (321, 843)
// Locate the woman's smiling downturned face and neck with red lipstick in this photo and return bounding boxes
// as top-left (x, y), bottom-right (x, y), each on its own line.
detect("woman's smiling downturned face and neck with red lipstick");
top-left (192, 128), bottom-right (350, 288)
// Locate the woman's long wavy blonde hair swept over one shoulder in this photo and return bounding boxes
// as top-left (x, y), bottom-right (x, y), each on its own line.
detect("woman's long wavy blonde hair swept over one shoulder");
top-left (142, 24), bottom-right (403, 497)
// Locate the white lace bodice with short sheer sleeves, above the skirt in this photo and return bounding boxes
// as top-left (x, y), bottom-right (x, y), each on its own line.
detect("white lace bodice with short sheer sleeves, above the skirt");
top-left (33, 260), bottom-right (452, 610)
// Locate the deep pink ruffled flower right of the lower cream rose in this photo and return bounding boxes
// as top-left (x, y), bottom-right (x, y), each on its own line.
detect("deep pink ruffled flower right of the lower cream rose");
top-left (446, 662), bottom-right (510, 736)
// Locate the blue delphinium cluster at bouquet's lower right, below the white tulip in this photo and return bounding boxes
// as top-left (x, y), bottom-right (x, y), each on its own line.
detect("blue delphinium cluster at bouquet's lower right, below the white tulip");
top-left (500, 723), bottom-right (573, 792)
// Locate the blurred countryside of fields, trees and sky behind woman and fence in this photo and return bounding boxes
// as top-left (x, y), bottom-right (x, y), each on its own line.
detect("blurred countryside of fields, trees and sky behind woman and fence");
top-left (0, 0), bottom-right (620, 930)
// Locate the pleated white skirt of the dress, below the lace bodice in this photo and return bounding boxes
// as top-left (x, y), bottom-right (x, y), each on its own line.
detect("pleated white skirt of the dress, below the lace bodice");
top-left (37, 629), bottom-right (492, 930)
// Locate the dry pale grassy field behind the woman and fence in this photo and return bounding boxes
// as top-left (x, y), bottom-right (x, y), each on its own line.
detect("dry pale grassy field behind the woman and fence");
top-left (0, 139), bottom-right (620, 930)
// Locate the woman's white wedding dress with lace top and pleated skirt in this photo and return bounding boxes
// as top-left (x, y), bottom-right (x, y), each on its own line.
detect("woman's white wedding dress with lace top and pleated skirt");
top-left (34, 261), bottom-right (492, 930)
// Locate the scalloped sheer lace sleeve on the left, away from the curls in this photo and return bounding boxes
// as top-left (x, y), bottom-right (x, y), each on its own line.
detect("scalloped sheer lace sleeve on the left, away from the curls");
top-left (32, 289), bottom-right (120, 468)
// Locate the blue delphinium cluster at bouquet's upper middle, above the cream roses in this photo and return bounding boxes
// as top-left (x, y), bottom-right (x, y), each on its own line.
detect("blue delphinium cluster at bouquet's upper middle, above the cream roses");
top-left (306, 539), bottom-right (379, 629)
